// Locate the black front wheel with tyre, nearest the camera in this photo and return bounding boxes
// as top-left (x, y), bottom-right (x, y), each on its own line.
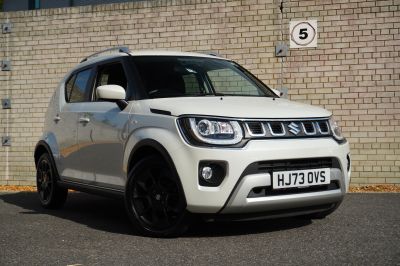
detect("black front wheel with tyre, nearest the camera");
top-left (125, 156), bottom-right (189, 237)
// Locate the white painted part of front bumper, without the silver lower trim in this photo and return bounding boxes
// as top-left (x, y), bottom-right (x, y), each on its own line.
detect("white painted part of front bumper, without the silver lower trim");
top-left (167, 134), bottom-right (350, 213)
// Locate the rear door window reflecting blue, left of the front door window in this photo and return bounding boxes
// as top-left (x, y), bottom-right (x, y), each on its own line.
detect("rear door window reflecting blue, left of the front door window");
top-left (65, 69), bottom-right (92, 103)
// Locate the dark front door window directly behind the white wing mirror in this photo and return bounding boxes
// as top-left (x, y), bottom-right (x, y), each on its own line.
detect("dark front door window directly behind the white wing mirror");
top-left (93, 63), bottom-right (128, 101)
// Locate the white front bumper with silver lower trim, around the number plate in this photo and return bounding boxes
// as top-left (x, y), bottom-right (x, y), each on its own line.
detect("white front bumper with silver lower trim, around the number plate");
top-left (171, 138), bottom-right (350, 214)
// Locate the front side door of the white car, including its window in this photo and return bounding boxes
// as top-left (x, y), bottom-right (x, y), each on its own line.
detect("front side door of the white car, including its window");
top-left (78, 61), bottom-right (129, 189)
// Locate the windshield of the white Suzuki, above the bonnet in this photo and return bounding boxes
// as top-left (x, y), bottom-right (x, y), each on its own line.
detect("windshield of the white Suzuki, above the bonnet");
top-left (131, 56), bottom-right (276, 98)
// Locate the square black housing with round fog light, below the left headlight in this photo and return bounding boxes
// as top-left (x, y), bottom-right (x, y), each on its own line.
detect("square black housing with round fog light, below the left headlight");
top-left (199, 161), bottom-right (226, 187)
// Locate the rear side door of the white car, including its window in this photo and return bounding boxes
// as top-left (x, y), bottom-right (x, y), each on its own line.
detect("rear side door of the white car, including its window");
top-left (54, 67), bottom-right (94, 182)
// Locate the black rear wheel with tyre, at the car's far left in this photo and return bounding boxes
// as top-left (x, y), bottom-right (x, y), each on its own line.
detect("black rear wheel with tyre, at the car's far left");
top-left (36, 153), bottom-right (68, 209)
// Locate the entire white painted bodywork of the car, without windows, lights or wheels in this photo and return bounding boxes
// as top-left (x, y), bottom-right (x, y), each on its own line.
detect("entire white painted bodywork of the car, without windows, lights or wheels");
top-left (36, 51), bottom-right (350, 220)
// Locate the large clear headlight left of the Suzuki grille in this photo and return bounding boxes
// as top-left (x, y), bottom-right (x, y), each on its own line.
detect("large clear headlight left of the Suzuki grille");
top-left (179, 117), bottom-right (243, 145)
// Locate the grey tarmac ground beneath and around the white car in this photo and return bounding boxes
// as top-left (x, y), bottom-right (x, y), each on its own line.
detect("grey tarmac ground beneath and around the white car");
top-left (0, 192), bottom-right (400, 265)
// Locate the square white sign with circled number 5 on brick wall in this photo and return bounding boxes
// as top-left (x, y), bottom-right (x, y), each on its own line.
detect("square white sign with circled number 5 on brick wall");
top-left (289, 20), bottom-right (317, 48)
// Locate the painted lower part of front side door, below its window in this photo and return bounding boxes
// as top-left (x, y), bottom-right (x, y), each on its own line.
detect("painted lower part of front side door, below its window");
top-left (77, 102), bottom-right (129, 187)
